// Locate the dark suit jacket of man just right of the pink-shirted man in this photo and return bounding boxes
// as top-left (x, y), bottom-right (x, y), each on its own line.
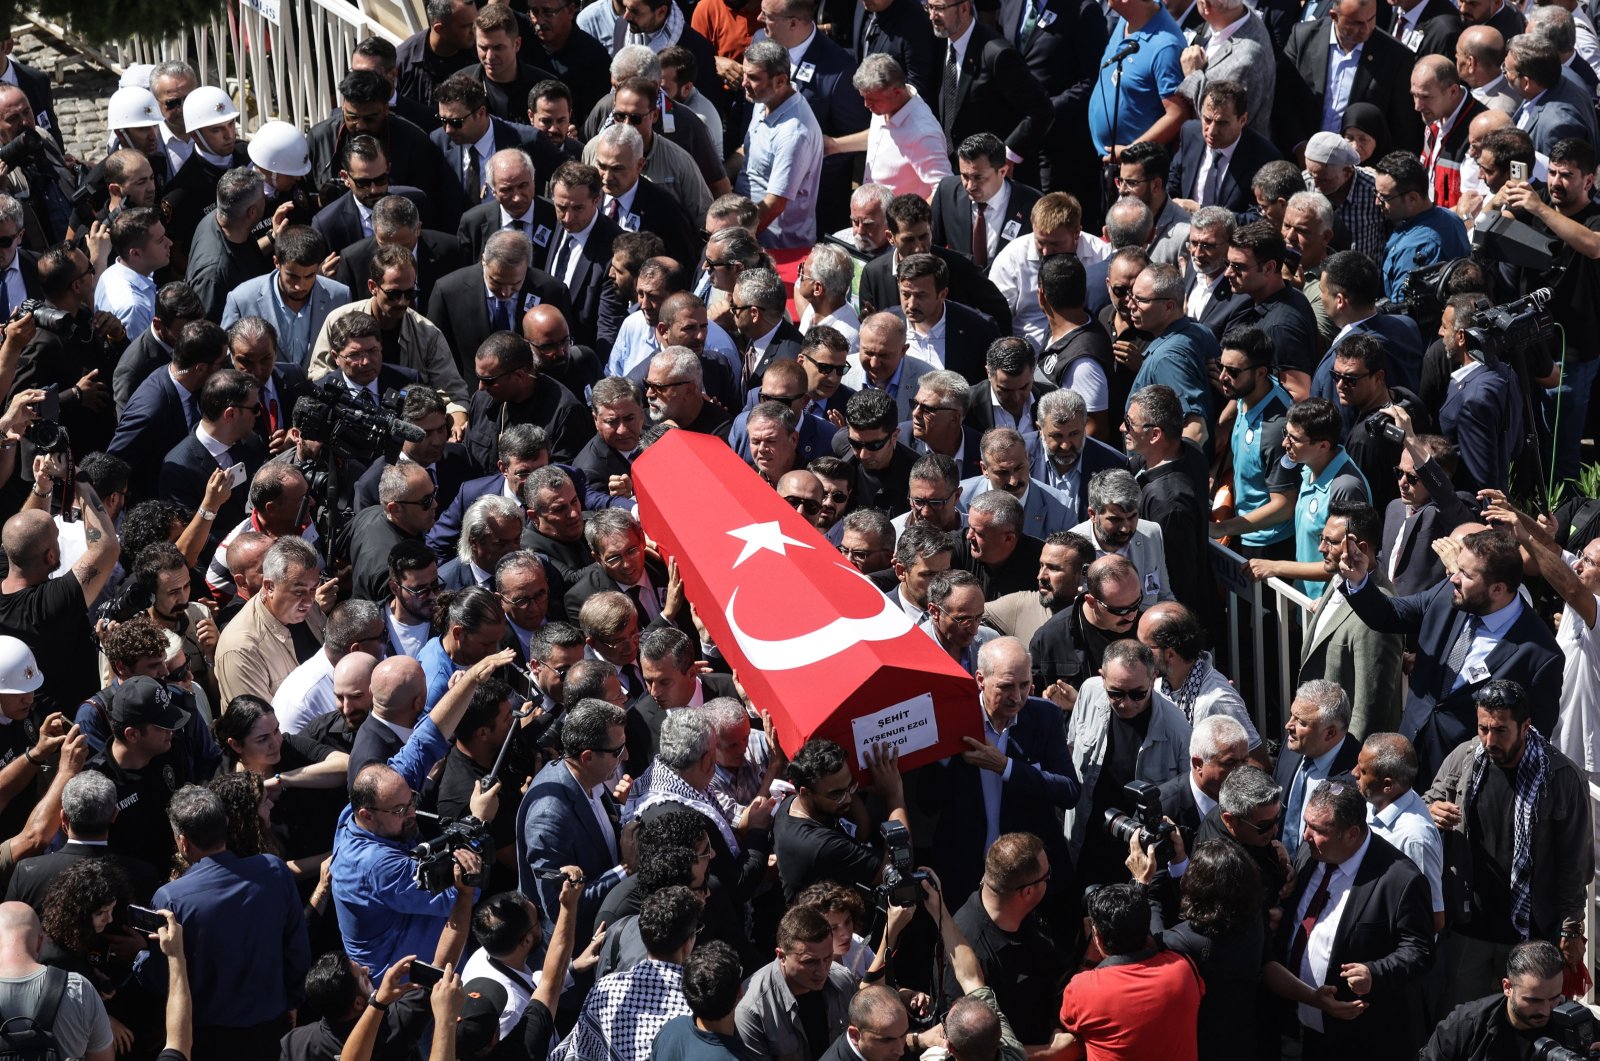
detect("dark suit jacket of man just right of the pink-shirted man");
top-left (928, 19), bottom-right (1056, 166)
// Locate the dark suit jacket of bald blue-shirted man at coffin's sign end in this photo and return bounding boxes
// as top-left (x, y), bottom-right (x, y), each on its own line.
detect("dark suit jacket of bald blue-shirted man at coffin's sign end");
top-left (917, 696), bottom-right (1080, 903)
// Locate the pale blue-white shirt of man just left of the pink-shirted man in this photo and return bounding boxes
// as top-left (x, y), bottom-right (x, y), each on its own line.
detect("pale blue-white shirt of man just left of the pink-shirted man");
top-left (734, 91), bottom-right (822, 250)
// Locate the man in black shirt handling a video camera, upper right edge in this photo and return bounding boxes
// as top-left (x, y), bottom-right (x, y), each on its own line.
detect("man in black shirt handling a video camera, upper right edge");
top-left (1501, 138), bottom-right (1600, 480)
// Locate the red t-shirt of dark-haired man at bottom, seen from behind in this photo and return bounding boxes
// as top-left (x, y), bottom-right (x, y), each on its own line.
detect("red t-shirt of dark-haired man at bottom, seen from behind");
top-left (1061, 951), bottom-right (1205, 1061)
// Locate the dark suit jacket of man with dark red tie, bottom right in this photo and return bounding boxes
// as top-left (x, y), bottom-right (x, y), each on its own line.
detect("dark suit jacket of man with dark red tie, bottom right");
top-left (1277, 835), bottom-right (1434, 1061)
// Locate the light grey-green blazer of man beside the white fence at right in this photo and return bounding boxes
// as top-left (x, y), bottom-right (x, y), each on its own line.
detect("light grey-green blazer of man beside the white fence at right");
top-left (1299, 571), bottom-right (1405, 741)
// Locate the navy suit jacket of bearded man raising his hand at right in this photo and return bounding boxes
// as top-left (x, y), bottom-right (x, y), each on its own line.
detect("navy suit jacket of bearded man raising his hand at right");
top-left (1350, 579), bottom-right (1565, 789)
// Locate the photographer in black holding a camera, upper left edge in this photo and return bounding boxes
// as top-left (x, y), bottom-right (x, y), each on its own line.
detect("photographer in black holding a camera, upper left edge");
top-left (14, 245), bottom-right (128, 456)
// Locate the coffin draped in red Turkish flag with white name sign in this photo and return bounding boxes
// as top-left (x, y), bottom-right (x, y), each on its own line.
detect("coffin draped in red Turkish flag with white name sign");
top-left (634, 430), bottom-right (982, 770)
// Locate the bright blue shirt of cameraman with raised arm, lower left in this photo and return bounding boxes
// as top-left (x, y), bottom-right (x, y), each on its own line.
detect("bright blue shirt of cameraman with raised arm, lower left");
top-left (333, 715), bottom-right (456, 978)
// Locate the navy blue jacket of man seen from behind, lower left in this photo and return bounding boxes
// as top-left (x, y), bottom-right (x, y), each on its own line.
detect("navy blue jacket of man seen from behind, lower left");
top-left (150, 851), bottom-right (310, 1027)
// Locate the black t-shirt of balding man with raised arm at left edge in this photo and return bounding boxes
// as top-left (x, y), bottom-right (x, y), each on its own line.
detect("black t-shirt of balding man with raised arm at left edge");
top-left (0, 571), bottom-right (99, 720)
